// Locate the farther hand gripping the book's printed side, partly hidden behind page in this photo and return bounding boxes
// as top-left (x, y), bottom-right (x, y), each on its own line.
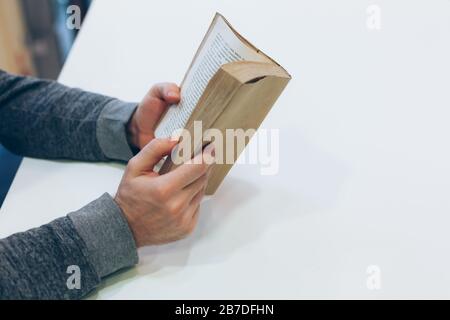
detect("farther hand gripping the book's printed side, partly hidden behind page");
top-left (127, 83), bottom-right (180, 150)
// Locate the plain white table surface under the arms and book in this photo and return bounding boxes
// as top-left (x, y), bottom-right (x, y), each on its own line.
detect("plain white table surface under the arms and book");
top-left (0, 0), bottom-right (450, 299)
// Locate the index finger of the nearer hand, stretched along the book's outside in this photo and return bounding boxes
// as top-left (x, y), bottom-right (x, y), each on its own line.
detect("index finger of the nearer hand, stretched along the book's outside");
top-left (163, 147), bottom-right (215, 189)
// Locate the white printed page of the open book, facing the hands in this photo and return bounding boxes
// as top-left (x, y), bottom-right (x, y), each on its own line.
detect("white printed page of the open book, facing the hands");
top-left (155, 15), bottom-right (270, 138)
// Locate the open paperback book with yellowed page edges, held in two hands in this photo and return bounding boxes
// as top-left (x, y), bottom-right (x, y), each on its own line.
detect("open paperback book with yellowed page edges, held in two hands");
top-left (156, 13), bottom-right (291, 195)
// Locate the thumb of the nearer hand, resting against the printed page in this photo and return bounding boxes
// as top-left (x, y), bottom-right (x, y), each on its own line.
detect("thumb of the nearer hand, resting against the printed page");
top-left (129, 139), bottom-right (178, 176)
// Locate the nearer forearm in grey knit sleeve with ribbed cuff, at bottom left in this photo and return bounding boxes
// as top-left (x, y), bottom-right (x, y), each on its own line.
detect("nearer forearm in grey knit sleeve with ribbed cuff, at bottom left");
top-left (0, 195), bottom-right (138, 299)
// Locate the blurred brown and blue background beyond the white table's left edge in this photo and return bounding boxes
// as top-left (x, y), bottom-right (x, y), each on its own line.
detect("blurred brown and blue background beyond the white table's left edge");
top-left (0, 0), bottom-right (91, 207)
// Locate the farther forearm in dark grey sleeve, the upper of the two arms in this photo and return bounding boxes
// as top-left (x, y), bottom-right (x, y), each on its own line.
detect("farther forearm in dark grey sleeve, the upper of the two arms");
top-left (0, 71), bottom-right (136, 161)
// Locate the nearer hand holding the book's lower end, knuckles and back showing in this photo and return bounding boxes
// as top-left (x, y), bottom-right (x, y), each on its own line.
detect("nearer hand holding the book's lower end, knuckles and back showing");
top-left (114, 139), bottom-right (214, 247)
